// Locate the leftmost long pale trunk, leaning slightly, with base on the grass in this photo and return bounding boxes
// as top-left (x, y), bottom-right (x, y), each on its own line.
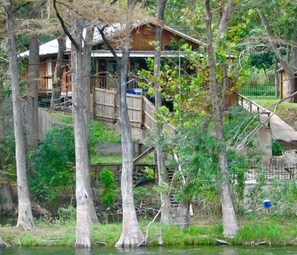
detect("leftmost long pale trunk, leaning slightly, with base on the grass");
top-left (5, 0), bottom-right (34, 230)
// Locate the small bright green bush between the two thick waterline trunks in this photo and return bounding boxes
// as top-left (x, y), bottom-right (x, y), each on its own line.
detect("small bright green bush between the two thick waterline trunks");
top-left (99, 167), bottom-right (117, 207)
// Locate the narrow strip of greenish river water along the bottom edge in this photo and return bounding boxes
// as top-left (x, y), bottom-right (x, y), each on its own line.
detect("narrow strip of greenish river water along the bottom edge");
top-left (0, 246), bottom-right (297, 255)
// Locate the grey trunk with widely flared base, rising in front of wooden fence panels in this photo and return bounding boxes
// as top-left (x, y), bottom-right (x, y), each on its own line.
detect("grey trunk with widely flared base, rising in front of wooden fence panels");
top-left (116, 0), bottom-right (144, 247)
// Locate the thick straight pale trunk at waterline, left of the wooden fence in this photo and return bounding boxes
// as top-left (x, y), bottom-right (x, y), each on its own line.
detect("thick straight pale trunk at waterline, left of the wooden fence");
top-left (71, 19), bottom-right (92, 248)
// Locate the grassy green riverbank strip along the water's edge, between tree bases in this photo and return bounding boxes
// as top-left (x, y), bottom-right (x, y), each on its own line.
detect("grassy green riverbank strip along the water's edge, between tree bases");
top-left (0, 216), bottom-right (297, 247)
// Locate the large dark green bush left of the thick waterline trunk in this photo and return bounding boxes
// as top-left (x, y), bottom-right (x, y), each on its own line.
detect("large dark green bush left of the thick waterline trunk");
top-left (29, 126), bottom-right (75, 206)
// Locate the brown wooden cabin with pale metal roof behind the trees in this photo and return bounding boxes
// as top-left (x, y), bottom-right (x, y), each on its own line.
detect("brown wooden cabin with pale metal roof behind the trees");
top-left (20, 23), bottom-right (205, 99)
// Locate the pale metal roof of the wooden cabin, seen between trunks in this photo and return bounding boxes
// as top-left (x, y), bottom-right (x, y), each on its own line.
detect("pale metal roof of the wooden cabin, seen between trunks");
top-left (19, 22), bottom-right (206, 57)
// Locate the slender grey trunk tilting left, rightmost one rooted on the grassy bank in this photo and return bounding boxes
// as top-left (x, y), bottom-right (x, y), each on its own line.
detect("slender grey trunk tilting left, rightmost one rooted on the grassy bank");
top-left (205, 0), bottom-right (238, 236)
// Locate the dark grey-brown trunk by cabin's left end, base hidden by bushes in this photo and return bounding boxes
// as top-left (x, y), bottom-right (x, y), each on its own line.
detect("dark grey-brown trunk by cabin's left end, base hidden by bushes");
top-left (27, 35), bottom-right (40, 151)
